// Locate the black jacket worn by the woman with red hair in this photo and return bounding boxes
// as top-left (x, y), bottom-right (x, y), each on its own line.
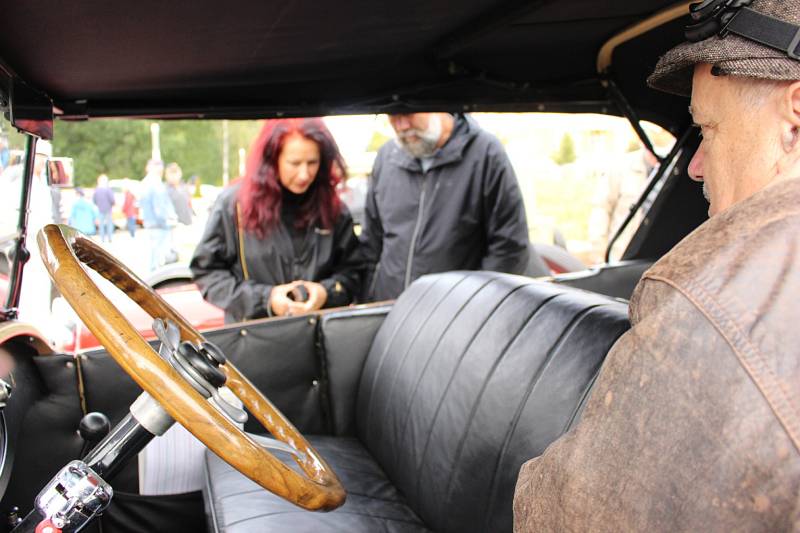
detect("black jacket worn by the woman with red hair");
top-left (190, 185), bottom-right (363, 322)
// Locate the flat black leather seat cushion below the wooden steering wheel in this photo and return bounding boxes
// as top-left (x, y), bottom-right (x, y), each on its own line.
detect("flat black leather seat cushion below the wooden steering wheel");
top-left (204, 436), bottom-right (429, 533)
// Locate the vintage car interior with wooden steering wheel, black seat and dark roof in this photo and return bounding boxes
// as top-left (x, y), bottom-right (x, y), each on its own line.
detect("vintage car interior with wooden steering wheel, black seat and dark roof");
top-left (0, 0), bottom-right (707, 532)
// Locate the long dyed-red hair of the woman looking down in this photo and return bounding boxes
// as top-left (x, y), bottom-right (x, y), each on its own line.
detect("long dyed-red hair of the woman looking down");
top-left (239, 118), bottom-right (346, 238)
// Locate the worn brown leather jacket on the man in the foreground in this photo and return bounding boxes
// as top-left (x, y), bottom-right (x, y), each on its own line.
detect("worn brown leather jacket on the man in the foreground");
top-left (514, 179), bottom-right (800, 531)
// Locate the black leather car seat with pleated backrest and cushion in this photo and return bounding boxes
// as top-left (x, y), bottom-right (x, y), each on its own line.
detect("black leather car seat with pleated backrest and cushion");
top-left (205, 272), bottom-right (629, 532)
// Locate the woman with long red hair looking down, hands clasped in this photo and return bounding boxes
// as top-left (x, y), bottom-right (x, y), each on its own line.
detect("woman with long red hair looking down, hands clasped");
top-left (190, 118), bottom-right (362, 322)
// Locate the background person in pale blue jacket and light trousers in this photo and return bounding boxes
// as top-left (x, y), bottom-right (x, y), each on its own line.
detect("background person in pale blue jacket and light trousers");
top-left (139, 159), bottom-right (177, 271)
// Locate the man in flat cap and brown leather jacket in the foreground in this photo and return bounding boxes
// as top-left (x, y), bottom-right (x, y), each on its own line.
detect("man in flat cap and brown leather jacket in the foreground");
top-left (514, 0), bottom-right (800, 531)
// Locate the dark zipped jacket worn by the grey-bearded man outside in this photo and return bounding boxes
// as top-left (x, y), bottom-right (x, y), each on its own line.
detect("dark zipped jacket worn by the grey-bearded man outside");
top-left (361, 116), bottom-right (528, 300)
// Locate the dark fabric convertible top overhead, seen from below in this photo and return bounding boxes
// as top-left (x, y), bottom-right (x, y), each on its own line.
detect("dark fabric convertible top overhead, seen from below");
top-left (0, 0), bottom-right (687, 129)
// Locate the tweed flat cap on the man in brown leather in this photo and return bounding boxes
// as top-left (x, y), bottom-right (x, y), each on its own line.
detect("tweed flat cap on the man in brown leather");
top-left (647, 0), bottom-right (800, 96)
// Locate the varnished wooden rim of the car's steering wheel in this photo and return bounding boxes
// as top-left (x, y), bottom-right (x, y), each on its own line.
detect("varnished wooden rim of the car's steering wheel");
top-left (37, 224), bottom-right (346, 511)
